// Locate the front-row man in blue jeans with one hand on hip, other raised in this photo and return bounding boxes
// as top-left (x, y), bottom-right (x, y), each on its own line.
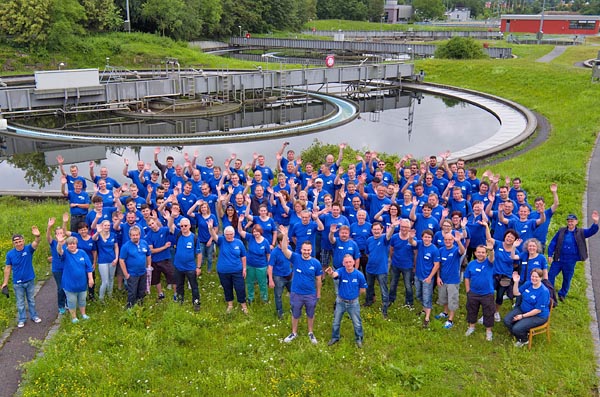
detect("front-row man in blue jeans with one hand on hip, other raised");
top-left (326, 254), bottom-right (367, 348)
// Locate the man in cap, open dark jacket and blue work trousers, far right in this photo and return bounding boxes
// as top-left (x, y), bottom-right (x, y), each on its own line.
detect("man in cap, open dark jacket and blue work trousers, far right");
top-left (548, 211), bottom-right (600, 301)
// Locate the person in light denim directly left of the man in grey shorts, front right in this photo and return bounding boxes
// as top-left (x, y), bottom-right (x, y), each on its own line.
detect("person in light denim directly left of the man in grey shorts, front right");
top-left (408, 229), bottom-right (440, 328)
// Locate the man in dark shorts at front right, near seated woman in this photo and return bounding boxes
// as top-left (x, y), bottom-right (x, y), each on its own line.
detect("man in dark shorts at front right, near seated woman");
top-left (464, 242), bottom-right (496, 342)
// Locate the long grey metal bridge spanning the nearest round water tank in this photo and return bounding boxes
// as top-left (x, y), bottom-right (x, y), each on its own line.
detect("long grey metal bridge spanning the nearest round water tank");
top-left (0, 63), bottom-right (415, 117)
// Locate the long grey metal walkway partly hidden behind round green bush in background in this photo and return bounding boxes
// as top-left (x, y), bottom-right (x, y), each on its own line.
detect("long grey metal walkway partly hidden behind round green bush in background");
top-left (229, 37), bottom-right (512, 58)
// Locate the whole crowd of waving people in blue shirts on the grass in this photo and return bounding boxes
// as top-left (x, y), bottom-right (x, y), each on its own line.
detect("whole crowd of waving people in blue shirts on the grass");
top-left (3, 143), bottom-right (599, 347)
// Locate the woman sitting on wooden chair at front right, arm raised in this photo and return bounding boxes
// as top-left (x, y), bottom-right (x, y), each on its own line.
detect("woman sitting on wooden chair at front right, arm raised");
top-left (504, 269), bottom-right (550, 347)
